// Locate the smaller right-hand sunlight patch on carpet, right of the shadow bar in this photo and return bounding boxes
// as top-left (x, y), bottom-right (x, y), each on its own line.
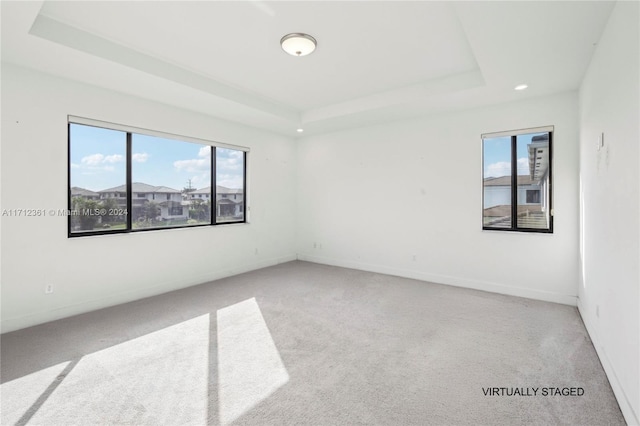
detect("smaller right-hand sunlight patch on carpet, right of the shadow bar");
top-left (217, 298), bottom-right (289, 425)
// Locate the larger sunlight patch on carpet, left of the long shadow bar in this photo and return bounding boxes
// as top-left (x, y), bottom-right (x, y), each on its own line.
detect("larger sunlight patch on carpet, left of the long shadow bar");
top-left (2, 314), bottom-right (210, 425)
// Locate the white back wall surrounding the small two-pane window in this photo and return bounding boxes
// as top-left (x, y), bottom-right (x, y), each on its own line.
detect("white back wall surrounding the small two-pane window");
top-left (297, 92), bottom-right (578, 305)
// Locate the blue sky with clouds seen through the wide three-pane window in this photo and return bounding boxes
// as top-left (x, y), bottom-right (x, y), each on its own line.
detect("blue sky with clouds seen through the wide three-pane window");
top-left (71, 124), bottom-right (243, 191)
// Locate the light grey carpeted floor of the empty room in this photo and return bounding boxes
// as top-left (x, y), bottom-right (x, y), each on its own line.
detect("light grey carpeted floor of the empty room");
top-left (0, 261), bottom-right (624, 425)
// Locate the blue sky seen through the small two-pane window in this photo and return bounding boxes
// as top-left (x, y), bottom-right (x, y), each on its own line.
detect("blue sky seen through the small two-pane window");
top-left (483, 133), bottom-right (543, 177)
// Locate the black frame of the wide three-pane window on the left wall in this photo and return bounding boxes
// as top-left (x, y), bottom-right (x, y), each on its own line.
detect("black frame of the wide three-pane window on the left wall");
top-left (67, 120), bottom-right (249, 238)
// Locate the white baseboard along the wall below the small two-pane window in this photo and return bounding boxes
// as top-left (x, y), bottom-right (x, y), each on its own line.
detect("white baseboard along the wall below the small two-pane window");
top-left (298, 254), bottom-right (577, 306)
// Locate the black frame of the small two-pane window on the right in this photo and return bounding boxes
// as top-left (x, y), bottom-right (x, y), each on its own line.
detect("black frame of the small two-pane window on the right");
top-left (481, 126), bottom-right (554, 234)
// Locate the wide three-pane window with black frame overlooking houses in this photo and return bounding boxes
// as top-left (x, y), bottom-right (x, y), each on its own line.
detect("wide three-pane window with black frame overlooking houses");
top-left (69, 117), bottom-right (246, 236)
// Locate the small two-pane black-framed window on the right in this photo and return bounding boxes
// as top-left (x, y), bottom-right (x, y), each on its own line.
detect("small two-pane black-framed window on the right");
top-left (482, 127), bottom-right (553, 232)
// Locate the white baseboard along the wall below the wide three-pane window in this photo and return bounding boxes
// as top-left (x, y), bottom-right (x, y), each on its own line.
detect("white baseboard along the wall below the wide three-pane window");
top-left (0, 254), bottom-right (297, 333)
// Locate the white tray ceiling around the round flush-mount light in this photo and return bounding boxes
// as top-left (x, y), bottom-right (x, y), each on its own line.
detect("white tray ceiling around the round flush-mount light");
top-left (1, 1), bottom-right (613, 137)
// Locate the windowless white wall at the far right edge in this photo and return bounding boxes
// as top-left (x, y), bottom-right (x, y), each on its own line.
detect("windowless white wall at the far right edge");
top-left (578, 2), bottom-right (640, 424)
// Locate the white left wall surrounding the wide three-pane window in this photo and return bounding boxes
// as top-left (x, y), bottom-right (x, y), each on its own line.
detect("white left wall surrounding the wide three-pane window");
top-left (1, 64), bottom-right (295, 332)
